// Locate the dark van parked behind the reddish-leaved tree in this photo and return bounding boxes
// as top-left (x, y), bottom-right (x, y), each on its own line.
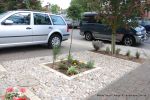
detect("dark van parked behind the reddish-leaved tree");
top-left (80, 12), bottom-right (147, 46)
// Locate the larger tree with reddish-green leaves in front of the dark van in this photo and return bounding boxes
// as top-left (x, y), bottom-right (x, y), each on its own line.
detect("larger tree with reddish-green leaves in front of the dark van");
top-left (88, 0), bottom-right (150, 54)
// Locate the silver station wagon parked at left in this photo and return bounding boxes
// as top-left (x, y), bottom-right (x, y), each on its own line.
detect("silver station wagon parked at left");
top-left (0, 10), bottom-right (69, 48)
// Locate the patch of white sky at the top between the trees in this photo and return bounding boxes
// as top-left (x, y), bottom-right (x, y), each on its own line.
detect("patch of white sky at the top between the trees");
top-left (41, 0), bottom-right (71, 9)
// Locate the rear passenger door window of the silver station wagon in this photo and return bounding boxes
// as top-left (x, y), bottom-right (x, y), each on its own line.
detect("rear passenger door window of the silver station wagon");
top-left (33, 13), bottom-right (51, 25)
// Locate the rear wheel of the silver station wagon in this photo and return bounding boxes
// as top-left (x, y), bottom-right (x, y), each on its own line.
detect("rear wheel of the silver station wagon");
top-left (48, 34), bottom-right (62, 48)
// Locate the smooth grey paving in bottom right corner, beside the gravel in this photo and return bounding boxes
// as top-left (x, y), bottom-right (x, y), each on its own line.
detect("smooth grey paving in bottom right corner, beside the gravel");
top-left (88, 60), bottom-right (150, 100)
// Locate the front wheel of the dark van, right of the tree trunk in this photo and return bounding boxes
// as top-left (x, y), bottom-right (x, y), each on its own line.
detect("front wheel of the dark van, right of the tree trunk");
top-left (123, 36), bottom-right (135, 46)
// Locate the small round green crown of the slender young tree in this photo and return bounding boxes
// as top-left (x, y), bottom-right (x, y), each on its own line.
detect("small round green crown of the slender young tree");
top-left (67, 5), bottom-right (82, 20)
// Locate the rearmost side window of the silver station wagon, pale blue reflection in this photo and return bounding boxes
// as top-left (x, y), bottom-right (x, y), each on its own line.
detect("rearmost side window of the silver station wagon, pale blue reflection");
top-left (51, 15), bottom-right (66, 25)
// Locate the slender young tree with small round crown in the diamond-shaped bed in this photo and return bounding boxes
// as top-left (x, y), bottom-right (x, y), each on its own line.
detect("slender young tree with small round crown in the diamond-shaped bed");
top-left (67, 5), bottom-right (82, 56)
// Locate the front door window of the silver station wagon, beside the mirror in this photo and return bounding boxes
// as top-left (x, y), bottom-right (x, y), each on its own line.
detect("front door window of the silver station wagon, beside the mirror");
top-left (5, 13), bottom-right (31, 25)
